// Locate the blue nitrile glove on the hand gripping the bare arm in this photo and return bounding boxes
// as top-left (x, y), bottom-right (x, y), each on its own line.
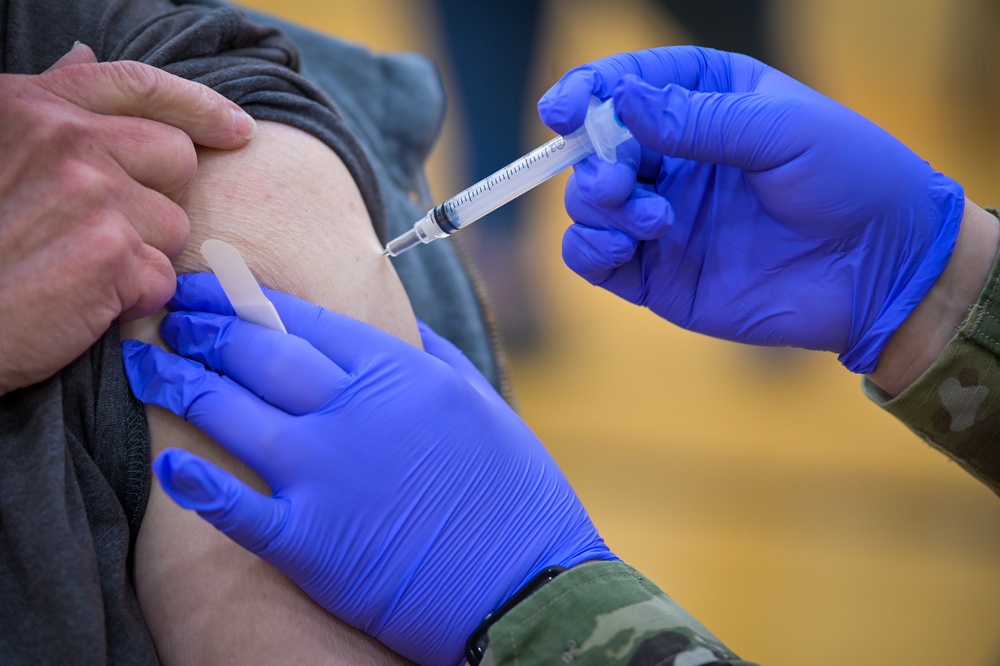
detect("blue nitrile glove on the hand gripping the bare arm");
top-left (123, 274), bottom-right (616, 665)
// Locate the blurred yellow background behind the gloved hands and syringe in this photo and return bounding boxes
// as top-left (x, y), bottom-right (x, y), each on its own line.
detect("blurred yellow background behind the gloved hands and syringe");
top-left (236, 0), bottom-right (1000, 666)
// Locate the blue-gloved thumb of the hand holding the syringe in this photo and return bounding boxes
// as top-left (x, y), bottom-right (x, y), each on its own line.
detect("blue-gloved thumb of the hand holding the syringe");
top-left (614, 77), bottom-right (787, 170)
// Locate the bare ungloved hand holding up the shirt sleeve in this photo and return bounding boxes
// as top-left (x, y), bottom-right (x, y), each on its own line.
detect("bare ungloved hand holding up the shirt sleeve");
top-left (0, 46), bottom-right (255, 395)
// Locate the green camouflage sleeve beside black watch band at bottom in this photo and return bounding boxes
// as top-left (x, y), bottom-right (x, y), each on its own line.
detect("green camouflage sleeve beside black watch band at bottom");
top-left (482, 562), bottom-right (753, 666)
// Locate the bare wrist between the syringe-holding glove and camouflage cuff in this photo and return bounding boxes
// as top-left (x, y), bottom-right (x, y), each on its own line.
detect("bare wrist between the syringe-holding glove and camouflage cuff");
top-left (868, 199), bottom-right (1000, 396)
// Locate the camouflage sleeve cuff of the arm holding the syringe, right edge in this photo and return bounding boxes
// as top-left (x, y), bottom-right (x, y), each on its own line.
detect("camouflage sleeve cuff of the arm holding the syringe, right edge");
top-left (863, 208), bottom-right (1000, 494)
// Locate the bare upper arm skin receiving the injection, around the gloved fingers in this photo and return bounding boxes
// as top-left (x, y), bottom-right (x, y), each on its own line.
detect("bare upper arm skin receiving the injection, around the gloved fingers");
top-left (123, 122), bottom-right (420, 664)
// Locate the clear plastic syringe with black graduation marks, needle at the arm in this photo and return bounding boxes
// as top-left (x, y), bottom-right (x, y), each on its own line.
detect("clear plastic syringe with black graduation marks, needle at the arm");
top-left (383, 97), bottom-right (632, 257)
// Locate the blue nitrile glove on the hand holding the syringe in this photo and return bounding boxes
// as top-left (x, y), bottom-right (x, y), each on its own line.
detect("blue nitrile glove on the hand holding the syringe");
top-left (538, 47), bottom-right (965, 372)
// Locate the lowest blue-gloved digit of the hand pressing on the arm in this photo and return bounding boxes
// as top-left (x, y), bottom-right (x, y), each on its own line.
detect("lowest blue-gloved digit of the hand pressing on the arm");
top-left (153, 449), bottom-right (286, 556)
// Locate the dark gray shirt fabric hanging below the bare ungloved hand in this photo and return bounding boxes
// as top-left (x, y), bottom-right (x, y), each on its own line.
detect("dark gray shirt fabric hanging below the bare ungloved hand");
top-left (0, 322), bottom-right (156, 664)
